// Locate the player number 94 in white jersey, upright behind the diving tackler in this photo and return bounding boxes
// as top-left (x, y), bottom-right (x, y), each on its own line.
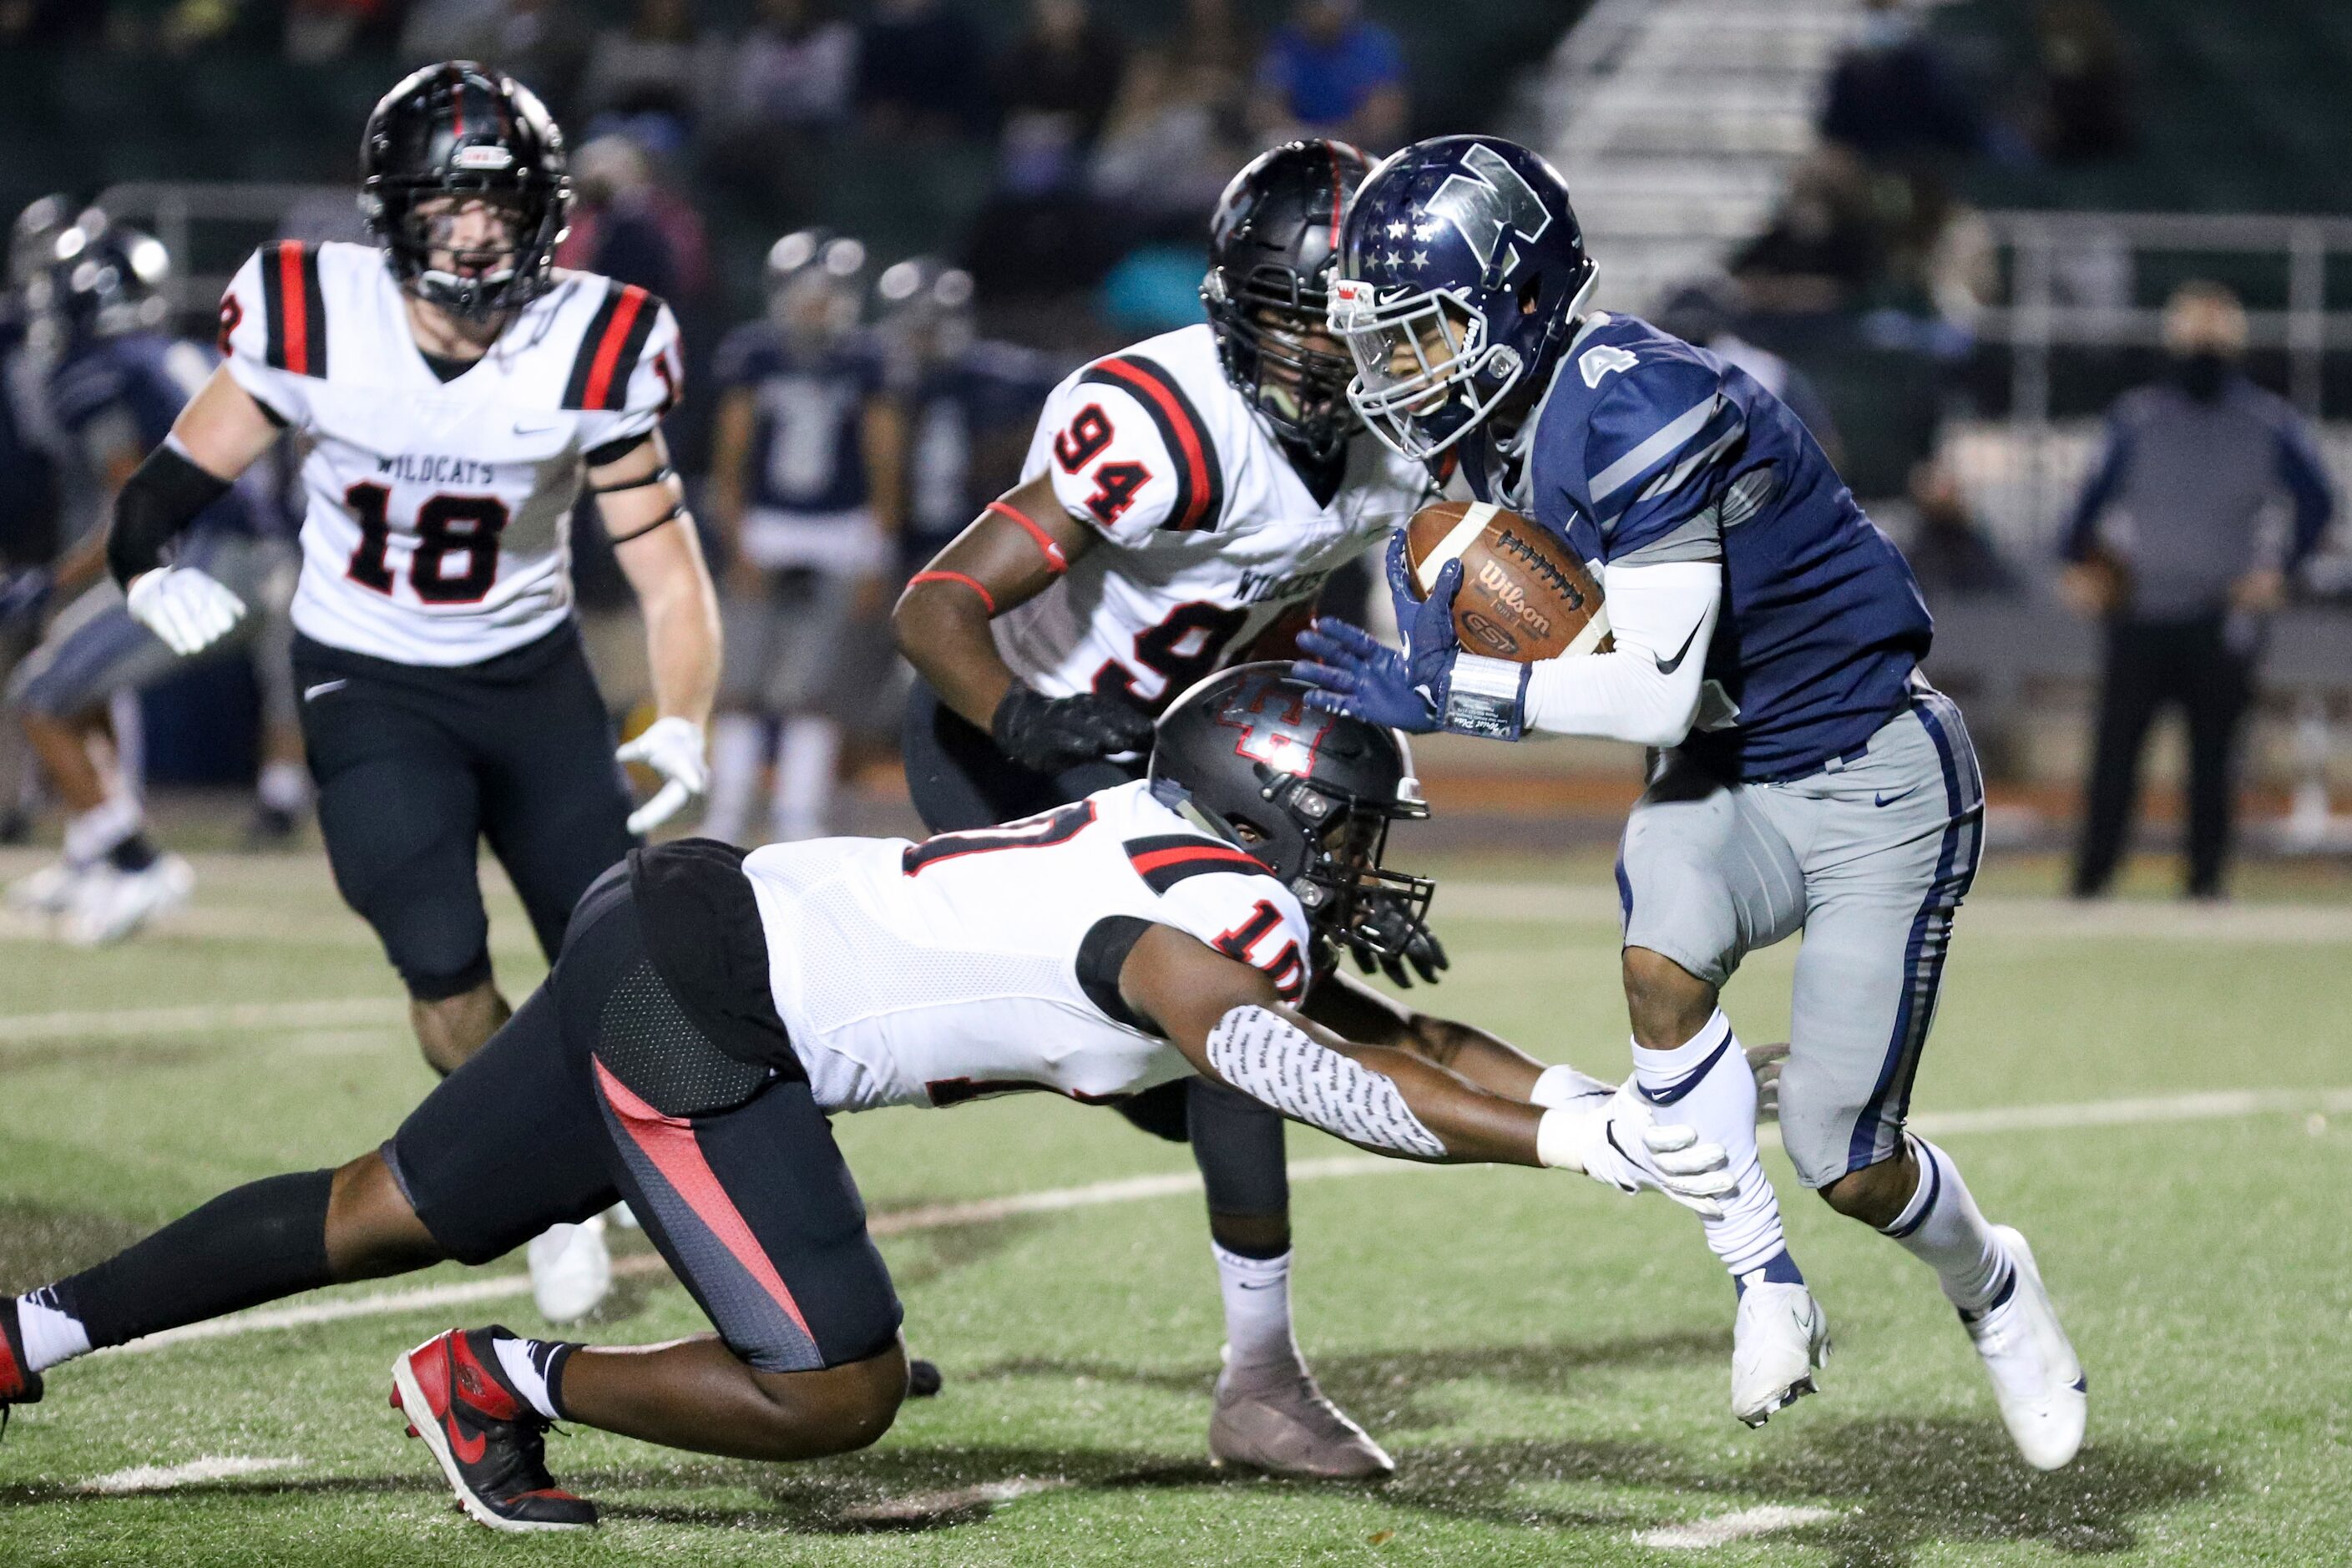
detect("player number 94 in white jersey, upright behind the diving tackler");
top-left (893, 141), bottom-right (1442, 1479)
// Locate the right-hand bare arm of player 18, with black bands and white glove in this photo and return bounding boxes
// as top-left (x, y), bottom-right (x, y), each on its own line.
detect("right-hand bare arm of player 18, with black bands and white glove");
top-left (588, 430), bottom-right (720, 832)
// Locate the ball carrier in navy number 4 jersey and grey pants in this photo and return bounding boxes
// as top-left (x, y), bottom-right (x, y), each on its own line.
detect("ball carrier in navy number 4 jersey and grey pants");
top-left (1298, 136), bottom-right (2086, 1469)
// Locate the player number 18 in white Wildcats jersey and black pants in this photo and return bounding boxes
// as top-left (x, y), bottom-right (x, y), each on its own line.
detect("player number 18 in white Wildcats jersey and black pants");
top-left (106, 61), bottom-right (720, 1317)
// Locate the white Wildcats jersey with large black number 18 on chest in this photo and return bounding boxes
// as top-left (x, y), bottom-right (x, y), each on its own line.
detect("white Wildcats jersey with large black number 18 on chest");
top-left (221, 240), bottom-right (685, 665)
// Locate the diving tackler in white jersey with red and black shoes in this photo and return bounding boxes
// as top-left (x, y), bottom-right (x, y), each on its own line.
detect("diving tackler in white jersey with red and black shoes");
top-left (0, 665), bottom-right (1731, 1530)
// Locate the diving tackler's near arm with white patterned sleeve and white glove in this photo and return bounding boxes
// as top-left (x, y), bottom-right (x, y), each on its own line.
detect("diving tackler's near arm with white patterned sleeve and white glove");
top-left (1120, 926), bottom-right (1733, 1213)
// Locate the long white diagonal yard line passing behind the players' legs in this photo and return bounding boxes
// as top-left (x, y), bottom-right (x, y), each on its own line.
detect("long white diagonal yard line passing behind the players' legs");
top-left (110, 1089), bottom-right (2352, 1354)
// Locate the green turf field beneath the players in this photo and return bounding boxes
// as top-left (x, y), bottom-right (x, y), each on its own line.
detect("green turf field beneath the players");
top-left (0, 841), bottom-right (2352, 1563)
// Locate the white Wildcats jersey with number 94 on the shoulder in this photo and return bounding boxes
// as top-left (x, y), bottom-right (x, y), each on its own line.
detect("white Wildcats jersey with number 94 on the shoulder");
top-left (993, 325), bottom-right (1428, 712)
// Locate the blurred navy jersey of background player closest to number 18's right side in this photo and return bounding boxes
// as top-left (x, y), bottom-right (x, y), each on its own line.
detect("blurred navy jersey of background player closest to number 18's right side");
top-left (713, 322), bottom-right (882, 513)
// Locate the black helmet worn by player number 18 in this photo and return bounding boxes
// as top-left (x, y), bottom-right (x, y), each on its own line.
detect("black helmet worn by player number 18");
top-left (360, 61), bottom-right (572, 322)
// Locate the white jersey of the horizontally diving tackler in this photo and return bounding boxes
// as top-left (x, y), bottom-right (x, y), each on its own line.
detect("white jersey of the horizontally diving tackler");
top-left (743, 781), bottom-right (1313, 1112)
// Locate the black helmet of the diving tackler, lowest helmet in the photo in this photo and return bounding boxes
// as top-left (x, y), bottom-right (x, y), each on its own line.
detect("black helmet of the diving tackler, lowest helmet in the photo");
top-left (1151, 663), bottom-right (1437, 966)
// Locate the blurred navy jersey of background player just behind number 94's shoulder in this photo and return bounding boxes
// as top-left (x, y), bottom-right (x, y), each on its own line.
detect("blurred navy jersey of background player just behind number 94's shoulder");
top-left (901, 343), bottom-right (1060, 567)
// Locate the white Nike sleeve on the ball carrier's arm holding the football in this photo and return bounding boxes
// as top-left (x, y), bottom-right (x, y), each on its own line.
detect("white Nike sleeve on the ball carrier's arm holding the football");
top-left (1526, 562), bottom-right (1724, 746)
